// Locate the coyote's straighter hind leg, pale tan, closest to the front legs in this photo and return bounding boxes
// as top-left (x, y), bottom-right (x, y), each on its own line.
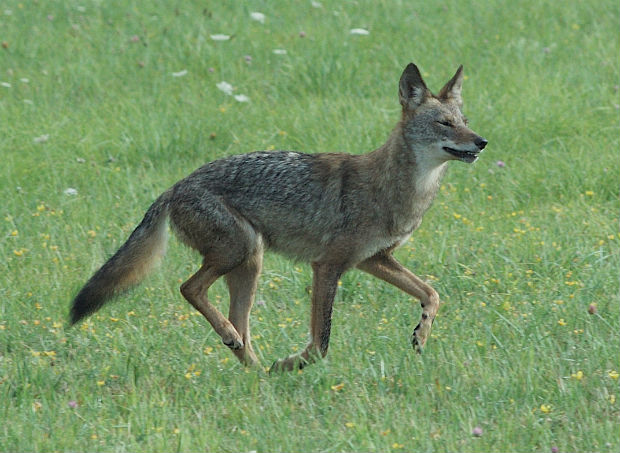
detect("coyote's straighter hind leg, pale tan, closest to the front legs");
top-left (224, 241), bottom-right (263, 365)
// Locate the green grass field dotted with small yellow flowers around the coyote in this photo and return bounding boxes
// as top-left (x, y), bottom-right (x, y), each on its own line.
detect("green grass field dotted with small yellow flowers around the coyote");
top-left (0, 0), bottom-right (620, 452)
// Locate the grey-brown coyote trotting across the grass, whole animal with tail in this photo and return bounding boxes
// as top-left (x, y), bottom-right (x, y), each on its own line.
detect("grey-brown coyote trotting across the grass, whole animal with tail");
top-left (70, 63), bottom-right (487, 371)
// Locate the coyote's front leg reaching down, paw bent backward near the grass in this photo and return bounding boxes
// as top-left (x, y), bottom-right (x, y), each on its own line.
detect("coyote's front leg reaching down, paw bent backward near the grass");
top-left (270, 263), bottom-right (343, 372)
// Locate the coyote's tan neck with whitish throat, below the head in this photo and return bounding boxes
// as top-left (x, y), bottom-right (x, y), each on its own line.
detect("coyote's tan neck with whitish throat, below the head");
top-left (368, 123), bottom-right (447, 233)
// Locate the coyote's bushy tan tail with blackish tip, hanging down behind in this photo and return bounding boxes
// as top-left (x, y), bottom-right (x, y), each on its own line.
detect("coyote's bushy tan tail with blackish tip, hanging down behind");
top-left (70, 192), bottom-right (169, 325)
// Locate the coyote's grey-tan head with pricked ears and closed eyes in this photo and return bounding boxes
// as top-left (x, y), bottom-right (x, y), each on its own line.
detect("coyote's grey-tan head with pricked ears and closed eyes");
top-left (399, 63), bottom-right (487, 163)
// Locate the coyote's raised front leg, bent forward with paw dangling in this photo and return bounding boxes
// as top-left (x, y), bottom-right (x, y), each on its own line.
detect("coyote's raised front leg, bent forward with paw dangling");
top-left (357, 252), bottom-right (439, 352)
